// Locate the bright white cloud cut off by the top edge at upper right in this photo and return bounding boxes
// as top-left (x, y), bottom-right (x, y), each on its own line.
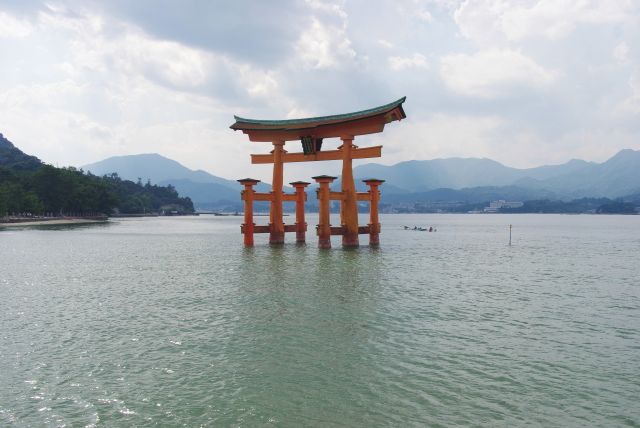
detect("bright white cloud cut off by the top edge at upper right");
top-left (454, 0), bottom-right (638, 43)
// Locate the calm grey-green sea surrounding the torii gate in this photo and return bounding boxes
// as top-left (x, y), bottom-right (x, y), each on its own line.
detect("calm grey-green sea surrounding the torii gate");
top-left (0, 215), bottom-right (640, 427)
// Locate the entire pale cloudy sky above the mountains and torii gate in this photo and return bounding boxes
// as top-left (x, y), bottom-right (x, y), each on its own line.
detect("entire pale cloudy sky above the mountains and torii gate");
top-left (0, 0), bottom-right (640, 181)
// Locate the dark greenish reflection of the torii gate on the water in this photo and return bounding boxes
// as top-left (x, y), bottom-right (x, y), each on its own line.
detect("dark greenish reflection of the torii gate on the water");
top-left (229, 244), bottom-right (384, 424)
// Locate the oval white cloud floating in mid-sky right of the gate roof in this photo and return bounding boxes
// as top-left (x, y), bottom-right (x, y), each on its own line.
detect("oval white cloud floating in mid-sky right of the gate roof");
top-left (440, 49), bottom-right (556, 98)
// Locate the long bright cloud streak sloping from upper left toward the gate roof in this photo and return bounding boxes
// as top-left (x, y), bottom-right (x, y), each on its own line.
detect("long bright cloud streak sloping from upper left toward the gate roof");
top-left (40, 6), bottom-right (278, 103)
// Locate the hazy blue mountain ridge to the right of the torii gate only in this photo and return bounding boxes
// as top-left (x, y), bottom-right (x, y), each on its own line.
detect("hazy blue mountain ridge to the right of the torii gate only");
top-left (354, 149), bottom-right (640, 200)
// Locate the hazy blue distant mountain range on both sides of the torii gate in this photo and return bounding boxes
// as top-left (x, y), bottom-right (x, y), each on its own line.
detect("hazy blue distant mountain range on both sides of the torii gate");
top-left (83, 149), bottom-right (640, 209)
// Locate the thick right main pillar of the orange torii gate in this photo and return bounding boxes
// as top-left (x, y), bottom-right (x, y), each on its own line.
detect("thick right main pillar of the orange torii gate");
top-left (340, 136), bottom-right (359, 247)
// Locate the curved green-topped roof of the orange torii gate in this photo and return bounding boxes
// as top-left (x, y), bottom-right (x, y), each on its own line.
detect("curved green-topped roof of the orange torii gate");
top-left (230, 97), bottom-right (407, 130)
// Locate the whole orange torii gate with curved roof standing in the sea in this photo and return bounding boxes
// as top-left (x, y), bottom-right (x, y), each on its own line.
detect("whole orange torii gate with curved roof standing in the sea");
top-left (231, 97), bottom-right (406, 248)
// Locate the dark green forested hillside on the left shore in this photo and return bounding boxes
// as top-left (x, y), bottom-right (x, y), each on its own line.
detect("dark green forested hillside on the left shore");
top-left (0, 135), bottom-right (193, 217)
